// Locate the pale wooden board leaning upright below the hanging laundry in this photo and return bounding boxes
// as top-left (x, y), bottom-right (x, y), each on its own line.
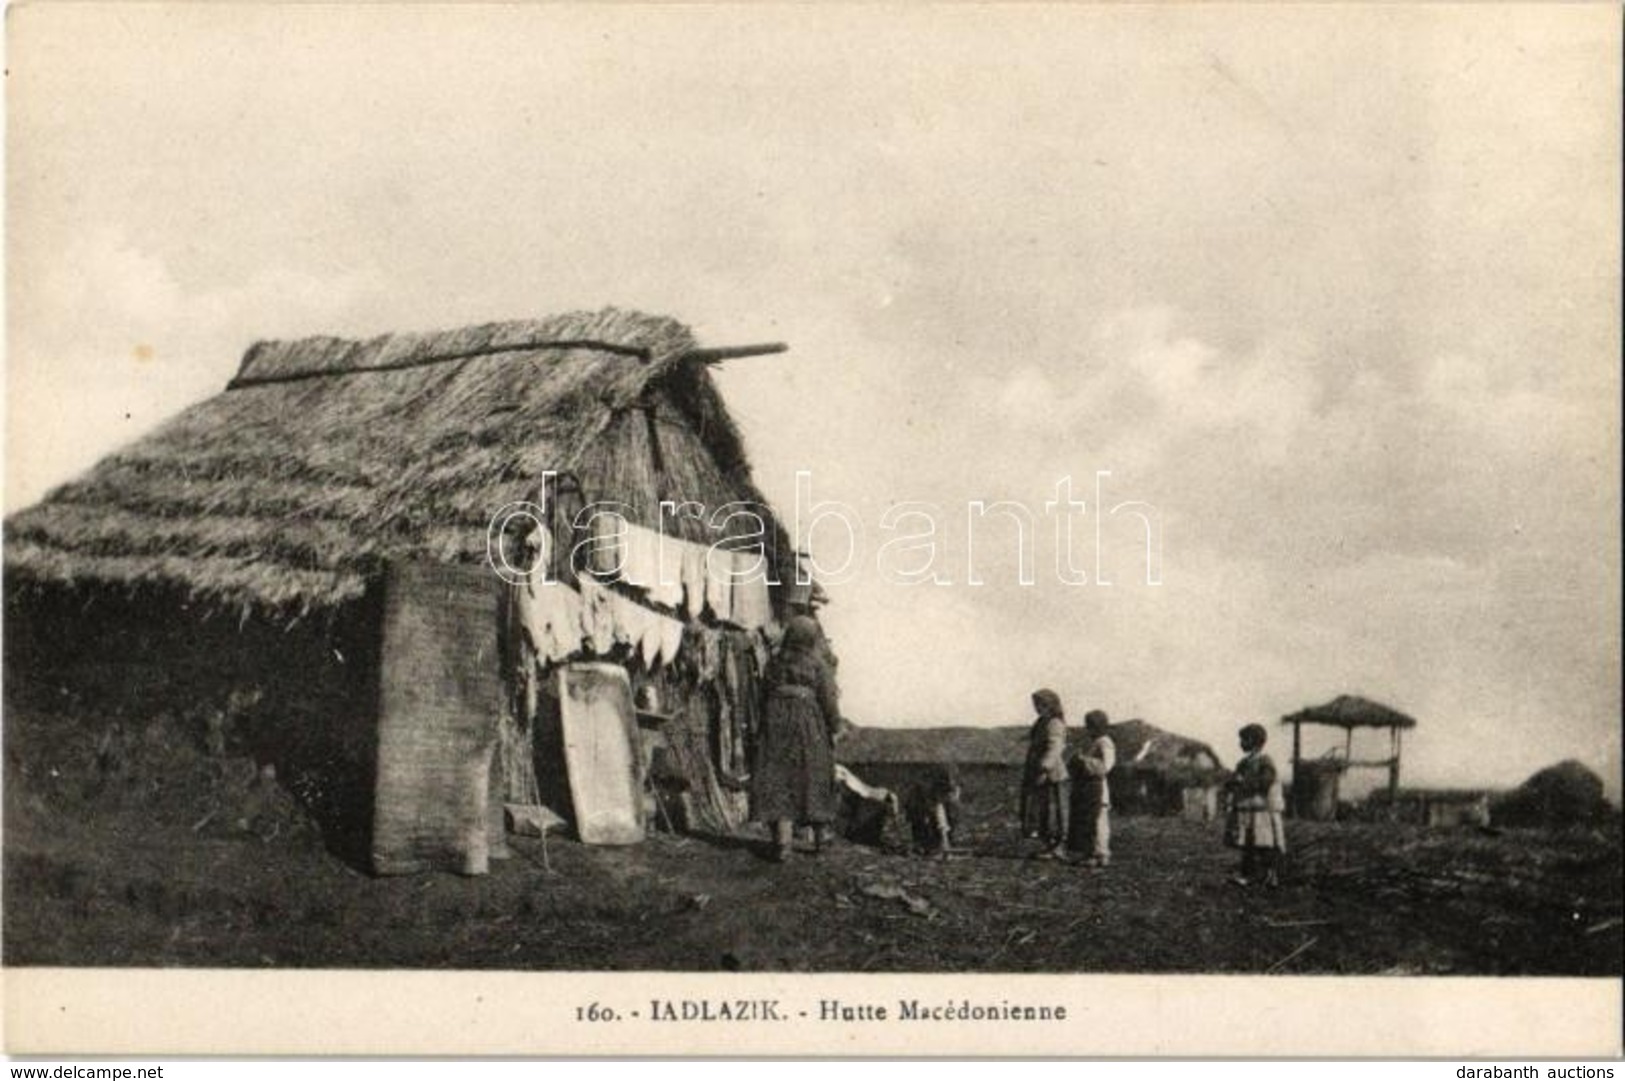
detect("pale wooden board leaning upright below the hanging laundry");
top-left (559, 662), bottom-right (644, 845)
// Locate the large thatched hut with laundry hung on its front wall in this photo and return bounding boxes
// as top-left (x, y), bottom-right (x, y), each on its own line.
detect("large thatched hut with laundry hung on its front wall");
top-left (5, 309), bottom-right (809, 870)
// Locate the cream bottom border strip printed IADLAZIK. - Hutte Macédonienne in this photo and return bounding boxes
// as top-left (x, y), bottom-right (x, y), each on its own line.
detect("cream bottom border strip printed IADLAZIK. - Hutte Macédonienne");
top-left (5, 969), bottom-right (1622, 1058)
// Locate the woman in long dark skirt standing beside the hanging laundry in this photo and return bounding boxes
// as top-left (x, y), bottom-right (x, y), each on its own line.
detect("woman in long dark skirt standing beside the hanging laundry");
top-left (751, 616), bottom-right (840, 862)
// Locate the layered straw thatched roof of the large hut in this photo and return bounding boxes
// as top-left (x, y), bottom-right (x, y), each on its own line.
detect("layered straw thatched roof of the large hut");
top-left (5, 309), bottom-right (777, 611)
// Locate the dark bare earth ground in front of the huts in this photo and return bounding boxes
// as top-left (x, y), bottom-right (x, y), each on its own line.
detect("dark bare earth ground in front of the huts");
top-left (3, 714), bottom-right (1625, 975)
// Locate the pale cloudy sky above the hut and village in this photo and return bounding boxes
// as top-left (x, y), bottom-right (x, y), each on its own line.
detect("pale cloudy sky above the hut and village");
top-left (5, 3), bottom-right (1622, 800)
